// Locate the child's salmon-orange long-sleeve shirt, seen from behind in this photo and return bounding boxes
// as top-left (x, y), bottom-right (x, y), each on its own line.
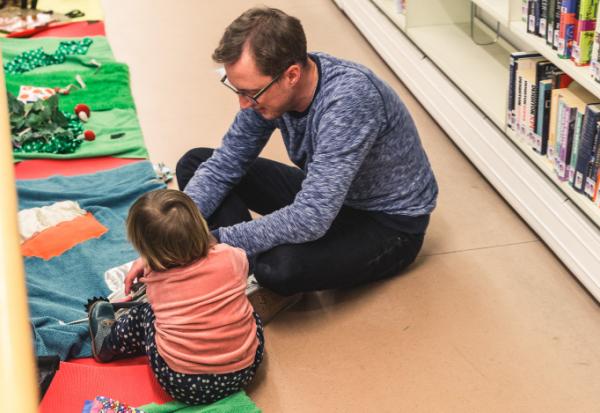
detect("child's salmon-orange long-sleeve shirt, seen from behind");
top-left (140, 244), bottom-right (258, 374)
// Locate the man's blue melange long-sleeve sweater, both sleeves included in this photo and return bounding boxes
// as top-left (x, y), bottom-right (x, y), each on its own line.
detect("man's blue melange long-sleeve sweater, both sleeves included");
top-left (185, 53), bottom-right (438, 255)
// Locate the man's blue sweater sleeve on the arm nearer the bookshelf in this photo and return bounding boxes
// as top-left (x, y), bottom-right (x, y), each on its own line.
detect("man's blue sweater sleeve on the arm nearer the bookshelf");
top-left (219, 75), bottom-right (385, 255)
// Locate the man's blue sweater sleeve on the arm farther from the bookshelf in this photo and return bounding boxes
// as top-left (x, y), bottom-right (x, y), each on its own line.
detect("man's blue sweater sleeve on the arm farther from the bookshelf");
top-left (184, 109), bottom-right (275, 217)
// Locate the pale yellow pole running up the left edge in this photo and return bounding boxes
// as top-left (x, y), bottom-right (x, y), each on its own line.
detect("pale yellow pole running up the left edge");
top-left (0, 55), bottom-right (38, 413)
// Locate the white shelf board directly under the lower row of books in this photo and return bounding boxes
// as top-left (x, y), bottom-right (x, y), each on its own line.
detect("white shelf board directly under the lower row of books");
top-left (505, 127), bottom-right (600, 228)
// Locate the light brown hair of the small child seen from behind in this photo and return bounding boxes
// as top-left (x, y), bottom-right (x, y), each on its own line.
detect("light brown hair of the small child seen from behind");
top-left (127, 189), bottom-right (211, 271)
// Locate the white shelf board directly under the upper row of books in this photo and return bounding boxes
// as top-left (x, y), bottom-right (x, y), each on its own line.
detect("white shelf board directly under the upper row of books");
top-left (510, 21), bottom-right (600, 98)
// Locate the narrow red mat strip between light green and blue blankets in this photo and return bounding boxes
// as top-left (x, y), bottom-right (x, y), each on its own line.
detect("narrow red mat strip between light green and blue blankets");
top-left (15, 156), bottom-right (143, 179)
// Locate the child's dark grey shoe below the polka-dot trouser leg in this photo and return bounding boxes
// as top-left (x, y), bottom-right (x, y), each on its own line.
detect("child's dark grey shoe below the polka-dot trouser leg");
top-left (88, 301), bottom-right (116, 363)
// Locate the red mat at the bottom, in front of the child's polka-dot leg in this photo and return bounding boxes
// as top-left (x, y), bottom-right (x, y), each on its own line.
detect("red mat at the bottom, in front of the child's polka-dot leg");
top-left (39, 357), bottom-right (173, 413)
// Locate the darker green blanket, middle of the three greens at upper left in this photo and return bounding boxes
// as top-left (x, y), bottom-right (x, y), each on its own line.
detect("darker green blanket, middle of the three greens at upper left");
top-left (6, 62), bottom-right (135, 112)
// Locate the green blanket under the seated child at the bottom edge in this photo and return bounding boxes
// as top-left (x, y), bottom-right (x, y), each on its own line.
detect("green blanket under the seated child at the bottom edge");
top-left (138, 391), bottom-right (260, 413)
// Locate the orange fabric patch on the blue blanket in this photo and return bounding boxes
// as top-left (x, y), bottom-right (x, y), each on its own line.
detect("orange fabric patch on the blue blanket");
top-left (21, 212), bottom-right (108, 260)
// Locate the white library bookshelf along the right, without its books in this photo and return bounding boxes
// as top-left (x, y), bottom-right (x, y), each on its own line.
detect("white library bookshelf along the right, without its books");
top-left (334, 0), bottom-right (600, 300)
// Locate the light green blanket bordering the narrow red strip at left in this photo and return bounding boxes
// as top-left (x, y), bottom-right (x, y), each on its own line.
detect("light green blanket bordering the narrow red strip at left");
top-left (13, 109), bottom-right (148, 162)
